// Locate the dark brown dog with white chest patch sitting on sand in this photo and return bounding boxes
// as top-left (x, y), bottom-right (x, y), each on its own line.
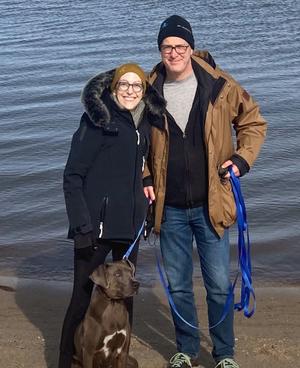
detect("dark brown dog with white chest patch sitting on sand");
top-left (72, 259), bottom-right (139, 368)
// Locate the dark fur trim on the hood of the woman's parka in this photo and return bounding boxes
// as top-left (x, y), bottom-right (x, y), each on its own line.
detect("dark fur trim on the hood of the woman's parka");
top-left (81, 69), bottom-right (166, 127)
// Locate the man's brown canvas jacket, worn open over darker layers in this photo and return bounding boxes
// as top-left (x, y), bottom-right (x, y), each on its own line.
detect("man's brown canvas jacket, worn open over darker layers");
top-left (144, 51), bottom-right (266, 237)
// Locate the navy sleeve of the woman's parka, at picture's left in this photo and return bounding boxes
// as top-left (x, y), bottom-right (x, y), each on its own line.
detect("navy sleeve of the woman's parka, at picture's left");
top-left (63, 114), bottom-right (101, 238)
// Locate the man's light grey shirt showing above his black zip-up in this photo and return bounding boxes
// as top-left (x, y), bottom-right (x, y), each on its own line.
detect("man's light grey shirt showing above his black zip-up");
top-left (164, 73), bottom-right (198, 132)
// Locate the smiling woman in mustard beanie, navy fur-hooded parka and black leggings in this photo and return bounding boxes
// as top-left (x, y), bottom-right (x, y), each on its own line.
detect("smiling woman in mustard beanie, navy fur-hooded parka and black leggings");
top-left (59, 64), bottom-right (165, 368)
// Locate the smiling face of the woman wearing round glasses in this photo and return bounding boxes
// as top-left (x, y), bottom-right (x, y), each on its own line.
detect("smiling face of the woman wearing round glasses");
top-left (115, 72), bottom-right (144, 110)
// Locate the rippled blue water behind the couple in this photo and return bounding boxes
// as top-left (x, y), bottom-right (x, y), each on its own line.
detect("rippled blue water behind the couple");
top-left (0, 0), bottom-right (300, 283)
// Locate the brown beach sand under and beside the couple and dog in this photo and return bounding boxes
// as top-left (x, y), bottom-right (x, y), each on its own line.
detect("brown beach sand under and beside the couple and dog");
top-left (0, 277), bottom-right (300, 368)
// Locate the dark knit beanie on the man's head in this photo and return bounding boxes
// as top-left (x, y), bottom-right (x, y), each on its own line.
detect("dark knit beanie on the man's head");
top-left (157, 15), bottom-right (195, 49)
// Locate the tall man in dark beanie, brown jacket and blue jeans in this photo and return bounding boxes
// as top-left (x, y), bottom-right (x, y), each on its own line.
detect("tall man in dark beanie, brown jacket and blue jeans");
top-left (144, 15), bottom-right (266, 368)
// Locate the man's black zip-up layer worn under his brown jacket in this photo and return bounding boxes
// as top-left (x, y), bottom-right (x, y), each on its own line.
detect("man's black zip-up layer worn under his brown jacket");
top-left (154, 62), bottom-right (214, 208)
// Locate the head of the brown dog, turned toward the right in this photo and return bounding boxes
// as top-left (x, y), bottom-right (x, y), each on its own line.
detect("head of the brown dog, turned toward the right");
top-left (90, 259), bottom-right (140, 299)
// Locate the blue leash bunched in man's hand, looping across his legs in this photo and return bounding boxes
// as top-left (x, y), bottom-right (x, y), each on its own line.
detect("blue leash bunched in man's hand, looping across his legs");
top-left (154, 166), bottom-right (256, 330)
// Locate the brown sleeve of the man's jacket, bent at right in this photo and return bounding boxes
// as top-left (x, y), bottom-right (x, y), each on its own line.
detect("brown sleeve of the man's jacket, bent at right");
top-left (228, 83), bottom-right (267, 167)
